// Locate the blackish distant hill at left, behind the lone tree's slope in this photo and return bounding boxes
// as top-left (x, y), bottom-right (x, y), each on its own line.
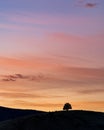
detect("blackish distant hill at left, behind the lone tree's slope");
top-left (0, 107), bottom-right (43, 122)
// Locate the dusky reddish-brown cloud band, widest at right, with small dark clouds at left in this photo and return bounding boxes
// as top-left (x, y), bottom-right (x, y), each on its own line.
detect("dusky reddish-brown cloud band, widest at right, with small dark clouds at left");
top-left (0, 66), bottom-right (104, 88)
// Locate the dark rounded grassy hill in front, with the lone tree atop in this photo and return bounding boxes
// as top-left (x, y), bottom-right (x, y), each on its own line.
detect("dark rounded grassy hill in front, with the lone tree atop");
top-left (0, 110), bottom-right (104, 130)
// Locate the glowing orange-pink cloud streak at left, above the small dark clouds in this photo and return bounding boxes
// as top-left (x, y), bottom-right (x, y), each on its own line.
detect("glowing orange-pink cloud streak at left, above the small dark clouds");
top-left (0, 57), bottom-right (53, 70)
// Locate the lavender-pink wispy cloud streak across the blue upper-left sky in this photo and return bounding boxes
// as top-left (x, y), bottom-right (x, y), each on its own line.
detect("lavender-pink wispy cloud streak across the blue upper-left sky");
top-left (0, 13), bottom-right (72, 27)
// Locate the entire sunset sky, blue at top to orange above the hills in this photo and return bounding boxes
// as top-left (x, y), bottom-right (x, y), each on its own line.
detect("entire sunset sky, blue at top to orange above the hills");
top-left (0, 0), bottom-right (104, 112)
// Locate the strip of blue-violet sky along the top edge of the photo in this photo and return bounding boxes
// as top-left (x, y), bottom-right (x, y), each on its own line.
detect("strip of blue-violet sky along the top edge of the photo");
top-left (0, 0), bottom-right (104, 15)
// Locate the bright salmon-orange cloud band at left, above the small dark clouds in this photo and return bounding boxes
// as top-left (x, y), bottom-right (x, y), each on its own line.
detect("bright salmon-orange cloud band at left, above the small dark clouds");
top-left (0, 56), bottom-right (54, 71)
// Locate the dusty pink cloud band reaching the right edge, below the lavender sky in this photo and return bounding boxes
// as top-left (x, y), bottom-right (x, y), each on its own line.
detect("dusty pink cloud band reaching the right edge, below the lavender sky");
top-left (44, 32), bottom-right (104, 45)
